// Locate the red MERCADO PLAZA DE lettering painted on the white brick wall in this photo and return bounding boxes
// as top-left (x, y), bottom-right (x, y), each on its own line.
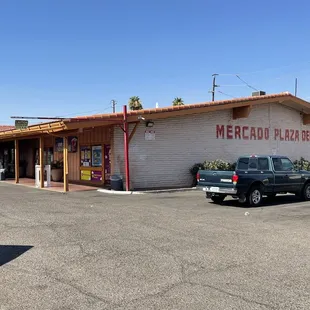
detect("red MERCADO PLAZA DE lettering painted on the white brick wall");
top-left (216, 125), bottom-right (310, 142)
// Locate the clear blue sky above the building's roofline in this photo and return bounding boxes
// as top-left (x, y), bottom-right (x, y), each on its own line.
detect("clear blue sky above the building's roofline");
top-left (0, 0), bottom-right (310, 124)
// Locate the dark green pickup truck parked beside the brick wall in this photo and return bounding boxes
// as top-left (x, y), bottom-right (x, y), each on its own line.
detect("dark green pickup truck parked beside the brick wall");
top-left (197, 155), bottom-right (310, 206)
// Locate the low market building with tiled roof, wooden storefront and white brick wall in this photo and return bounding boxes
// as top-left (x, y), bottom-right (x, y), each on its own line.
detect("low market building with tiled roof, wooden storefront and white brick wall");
top-left (0, 93), bottom-right (310, 189)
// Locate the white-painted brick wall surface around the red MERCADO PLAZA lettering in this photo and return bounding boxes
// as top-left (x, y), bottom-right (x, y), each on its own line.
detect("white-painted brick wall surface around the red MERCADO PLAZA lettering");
top-left (113, 104), bottom-right (310, 188)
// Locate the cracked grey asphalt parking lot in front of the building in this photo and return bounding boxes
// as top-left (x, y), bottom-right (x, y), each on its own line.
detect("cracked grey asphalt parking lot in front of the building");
top-left (0, 184), bottom-right (310, 310)
